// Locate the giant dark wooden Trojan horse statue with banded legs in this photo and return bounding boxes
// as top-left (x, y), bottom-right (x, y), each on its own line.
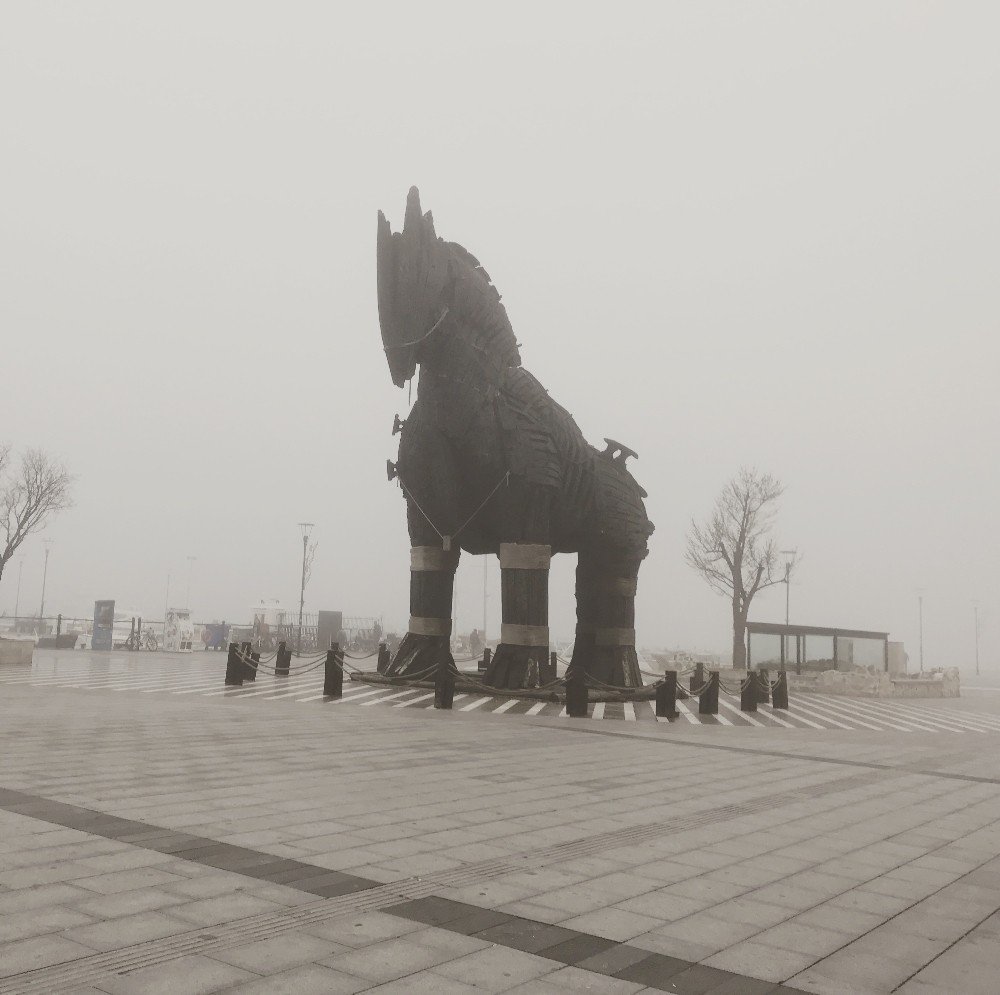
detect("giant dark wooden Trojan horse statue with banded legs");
top-left (377, 193), bottom-right (653, 688)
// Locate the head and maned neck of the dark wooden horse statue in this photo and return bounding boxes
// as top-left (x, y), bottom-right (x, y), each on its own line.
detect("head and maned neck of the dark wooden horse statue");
top-left (377, 187), bottom-right (521, 387)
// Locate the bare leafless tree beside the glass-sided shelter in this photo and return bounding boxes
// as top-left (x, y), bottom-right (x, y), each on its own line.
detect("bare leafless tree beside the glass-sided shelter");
top-left (684, 467), bottom-right (785, 669)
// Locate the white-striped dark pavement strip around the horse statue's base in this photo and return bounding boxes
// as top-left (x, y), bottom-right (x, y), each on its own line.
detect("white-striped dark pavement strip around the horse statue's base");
top-left (0, 653), bottom-right (1000, 734)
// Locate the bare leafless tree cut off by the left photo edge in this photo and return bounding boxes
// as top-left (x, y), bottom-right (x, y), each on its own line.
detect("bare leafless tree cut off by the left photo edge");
top-left (0, 445), bottom-right (73, 577)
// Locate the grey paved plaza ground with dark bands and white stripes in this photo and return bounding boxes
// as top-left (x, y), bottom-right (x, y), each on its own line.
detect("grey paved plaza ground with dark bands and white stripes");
top-left (0, 651), bottom-right (1000, 995)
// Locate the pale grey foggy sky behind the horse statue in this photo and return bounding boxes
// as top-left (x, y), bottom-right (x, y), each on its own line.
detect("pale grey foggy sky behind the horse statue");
top-left (0, 0), bottom-right (1000, 668)
